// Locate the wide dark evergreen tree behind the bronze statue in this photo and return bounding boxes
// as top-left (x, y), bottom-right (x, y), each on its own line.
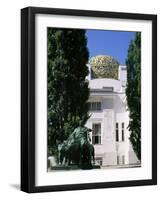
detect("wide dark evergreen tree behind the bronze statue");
top-left (47, 28), bottom-right (89, 158)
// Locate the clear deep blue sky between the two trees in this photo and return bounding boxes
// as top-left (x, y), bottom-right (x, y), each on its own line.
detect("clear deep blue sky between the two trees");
top-left (86, 30), bottom-right (135, 64)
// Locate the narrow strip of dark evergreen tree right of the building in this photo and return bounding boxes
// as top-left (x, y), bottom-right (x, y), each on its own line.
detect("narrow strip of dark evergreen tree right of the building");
top-left (126, 32), bottom-right (141, 160)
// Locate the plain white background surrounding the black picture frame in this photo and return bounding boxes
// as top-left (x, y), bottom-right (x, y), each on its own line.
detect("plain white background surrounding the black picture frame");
top-left (0, 0), bottom-right (161, 200)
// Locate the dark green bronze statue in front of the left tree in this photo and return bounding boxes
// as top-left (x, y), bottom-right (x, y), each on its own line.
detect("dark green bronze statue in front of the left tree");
top-left (59, 126), bottom-right (95, 169)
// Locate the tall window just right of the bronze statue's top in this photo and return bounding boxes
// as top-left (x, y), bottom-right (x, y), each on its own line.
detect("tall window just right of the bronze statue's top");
top-left (92, 123), bottom-right (101, 144)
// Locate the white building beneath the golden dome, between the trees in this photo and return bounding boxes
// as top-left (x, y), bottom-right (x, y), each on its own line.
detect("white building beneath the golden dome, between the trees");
top-left (86, 65), bottom-right (139, 166)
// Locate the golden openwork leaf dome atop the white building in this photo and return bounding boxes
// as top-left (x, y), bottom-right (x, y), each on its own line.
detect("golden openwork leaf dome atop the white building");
top-left (89, 55), bottom-right (119, 79)
